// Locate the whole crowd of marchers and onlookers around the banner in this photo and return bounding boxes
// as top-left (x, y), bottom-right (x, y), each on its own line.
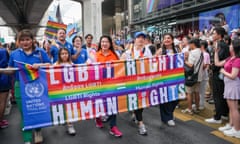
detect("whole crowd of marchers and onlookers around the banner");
top-left (0, 27), bottom-right (240, 144)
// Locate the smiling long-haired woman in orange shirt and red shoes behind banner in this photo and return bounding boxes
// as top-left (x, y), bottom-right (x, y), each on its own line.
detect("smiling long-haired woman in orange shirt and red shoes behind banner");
top-left (96, 36), bottom-right (122, 137)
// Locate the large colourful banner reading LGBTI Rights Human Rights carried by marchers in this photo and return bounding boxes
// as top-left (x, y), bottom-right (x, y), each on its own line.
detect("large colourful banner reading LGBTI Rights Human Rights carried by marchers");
top-left (19, 54), bottom-right (185, 130)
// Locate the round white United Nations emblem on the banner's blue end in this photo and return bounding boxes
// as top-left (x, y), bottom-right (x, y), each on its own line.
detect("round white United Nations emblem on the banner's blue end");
top-left (25, 82), bottom-right (44, 98)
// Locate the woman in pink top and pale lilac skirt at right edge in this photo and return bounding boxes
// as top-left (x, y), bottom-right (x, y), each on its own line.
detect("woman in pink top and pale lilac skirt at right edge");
top-left (214, 39), bottom-right (240, 138)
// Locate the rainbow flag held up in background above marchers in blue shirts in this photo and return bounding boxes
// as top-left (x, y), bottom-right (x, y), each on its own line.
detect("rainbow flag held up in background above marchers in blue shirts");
top-left (45, 21), bottom-right (67, 39)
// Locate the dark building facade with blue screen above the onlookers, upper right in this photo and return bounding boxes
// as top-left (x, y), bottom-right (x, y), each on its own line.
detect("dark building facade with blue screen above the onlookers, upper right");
top-left (129, 0), bottom-right (240, 39)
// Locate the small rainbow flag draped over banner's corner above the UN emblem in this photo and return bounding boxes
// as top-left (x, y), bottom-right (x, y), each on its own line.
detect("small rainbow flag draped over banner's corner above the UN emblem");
top-left (15, 61), bottom-right (39, 83)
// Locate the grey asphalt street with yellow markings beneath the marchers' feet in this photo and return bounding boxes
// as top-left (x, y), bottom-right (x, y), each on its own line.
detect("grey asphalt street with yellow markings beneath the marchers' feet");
top-left (0, 102), bottom-right (240, 144)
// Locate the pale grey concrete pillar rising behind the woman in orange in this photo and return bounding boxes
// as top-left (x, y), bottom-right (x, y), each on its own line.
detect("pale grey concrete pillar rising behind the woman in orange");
top-left (83, 0), bottom-right (103, 43)
